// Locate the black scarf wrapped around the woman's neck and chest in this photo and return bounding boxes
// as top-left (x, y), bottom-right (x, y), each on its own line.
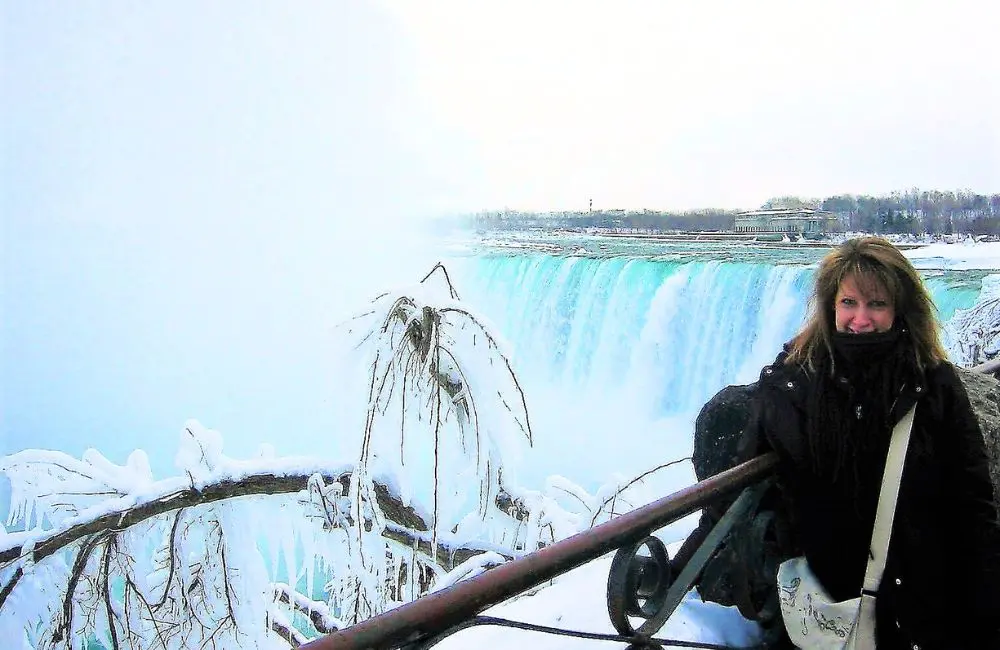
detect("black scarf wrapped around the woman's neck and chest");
top-left (806, 329), bottom-right (915, 498)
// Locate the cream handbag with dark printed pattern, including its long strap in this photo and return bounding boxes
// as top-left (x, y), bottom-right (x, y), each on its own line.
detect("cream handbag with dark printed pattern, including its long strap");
top-left (778, 405), bottom-right (917, 650)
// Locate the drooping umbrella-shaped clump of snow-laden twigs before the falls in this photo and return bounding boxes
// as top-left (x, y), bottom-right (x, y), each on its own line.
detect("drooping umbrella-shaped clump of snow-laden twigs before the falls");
top-left (348, 264), bottom-right (544, 603)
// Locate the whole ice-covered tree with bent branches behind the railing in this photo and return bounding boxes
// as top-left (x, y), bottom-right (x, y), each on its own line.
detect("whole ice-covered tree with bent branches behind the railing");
top-left (0, 265), bottom-right (668, 650)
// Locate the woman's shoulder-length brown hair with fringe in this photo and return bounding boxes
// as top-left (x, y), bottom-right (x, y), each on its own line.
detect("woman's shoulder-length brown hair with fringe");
top-left (786, 237), bottom-right (948, 371)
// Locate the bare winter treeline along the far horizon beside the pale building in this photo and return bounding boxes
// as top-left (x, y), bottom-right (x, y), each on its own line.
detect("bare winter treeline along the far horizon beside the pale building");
top-left (466, 188), bottom-right (1000, 236)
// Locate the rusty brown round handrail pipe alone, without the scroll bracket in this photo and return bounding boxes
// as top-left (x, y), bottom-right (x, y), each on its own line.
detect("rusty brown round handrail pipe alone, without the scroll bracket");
top-left (301, 452), bottom-right (778, 650)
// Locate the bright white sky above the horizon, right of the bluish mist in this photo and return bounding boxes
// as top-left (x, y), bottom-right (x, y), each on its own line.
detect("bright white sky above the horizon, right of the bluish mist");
top-left (378, 0), bottom-right (1000, 209)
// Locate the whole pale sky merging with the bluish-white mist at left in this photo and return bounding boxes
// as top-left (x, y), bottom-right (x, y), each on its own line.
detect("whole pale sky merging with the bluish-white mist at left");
top-left (0, 0), bottom-right (1000, 466)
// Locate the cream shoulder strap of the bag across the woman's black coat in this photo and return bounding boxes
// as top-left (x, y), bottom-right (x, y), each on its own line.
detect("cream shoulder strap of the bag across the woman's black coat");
top-left (861, 404), bottom-right (917, 595)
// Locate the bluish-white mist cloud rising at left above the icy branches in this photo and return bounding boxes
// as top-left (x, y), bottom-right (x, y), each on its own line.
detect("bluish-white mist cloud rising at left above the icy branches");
top-left (0, 0), bottom-right (457, 464)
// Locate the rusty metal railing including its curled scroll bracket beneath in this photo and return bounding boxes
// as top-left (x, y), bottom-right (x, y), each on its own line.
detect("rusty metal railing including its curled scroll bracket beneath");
top-left (301, 453), bottom-right (778, 650)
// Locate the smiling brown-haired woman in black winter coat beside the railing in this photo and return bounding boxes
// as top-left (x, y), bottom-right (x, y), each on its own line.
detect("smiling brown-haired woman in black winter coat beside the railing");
top-left (742, 237), bottom-right (1000, 650)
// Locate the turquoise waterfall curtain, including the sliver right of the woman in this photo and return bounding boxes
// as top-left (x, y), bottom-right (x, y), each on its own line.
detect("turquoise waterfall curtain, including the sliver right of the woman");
top-left (456, 251), bottom-right (978, 488)
